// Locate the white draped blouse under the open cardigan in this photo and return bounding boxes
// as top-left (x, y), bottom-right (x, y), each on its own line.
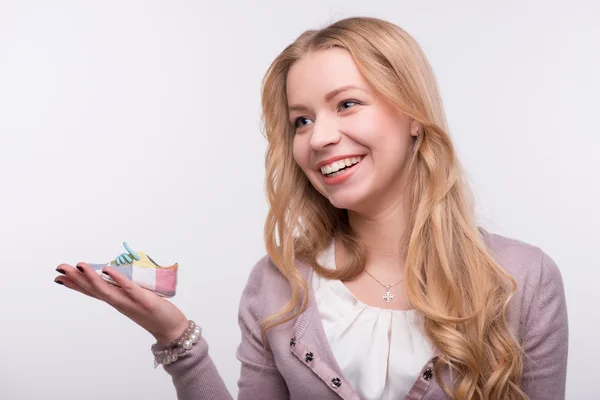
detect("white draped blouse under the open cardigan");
top-left (312, 241), bottom-right (434, 400)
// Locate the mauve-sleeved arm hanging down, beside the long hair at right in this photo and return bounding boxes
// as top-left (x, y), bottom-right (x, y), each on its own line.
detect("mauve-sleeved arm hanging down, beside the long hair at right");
top-left (521, 254), bottom-right (569, 400)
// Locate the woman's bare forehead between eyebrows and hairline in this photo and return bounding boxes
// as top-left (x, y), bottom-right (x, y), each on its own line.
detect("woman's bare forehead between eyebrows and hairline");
top-left (286, 48), bottom-right (369, 104)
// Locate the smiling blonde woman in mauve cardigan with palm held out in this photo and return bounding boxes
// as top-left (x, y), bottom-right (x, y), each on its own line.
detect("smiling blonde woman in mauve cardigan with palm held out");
top-left (57, 18), bottom-right (568, 400)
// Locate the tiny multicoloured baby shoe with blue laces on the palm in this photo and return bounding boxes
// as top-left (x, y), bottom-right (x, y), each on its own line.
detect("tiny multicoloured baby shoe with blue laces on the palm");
top-left (89, 242), bottom-right (178, 297)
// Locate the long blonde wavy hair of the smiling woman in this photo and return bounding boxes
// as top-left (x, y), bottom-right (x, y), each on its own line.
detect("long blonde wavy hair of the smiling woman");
top-left (261, 17), bottom-right (527, 400)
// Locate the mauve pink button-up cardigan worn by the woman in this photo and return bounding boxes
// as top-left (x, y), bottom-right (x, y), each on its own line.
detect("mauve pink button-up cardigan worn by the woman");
top-left (165, 230), bottom-right (568, 400)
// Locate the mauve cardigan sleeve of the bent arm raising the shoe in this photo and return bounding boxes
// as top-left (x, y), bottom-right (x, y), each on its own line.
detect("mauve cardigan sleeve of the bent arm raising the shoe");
top-left (164, 258), bottom-right (289, 400)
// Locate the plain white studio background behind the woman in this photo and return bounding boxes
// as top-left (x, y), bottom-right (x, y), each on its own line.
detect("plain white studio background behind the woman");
top-left (0, 0), bottom-right (600, 400)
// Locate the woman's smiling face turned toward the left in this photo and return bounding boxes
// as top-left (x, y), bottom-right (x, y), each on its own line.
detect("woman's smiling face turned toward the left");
top-left (287, 48), bottom-right (417, 213)
